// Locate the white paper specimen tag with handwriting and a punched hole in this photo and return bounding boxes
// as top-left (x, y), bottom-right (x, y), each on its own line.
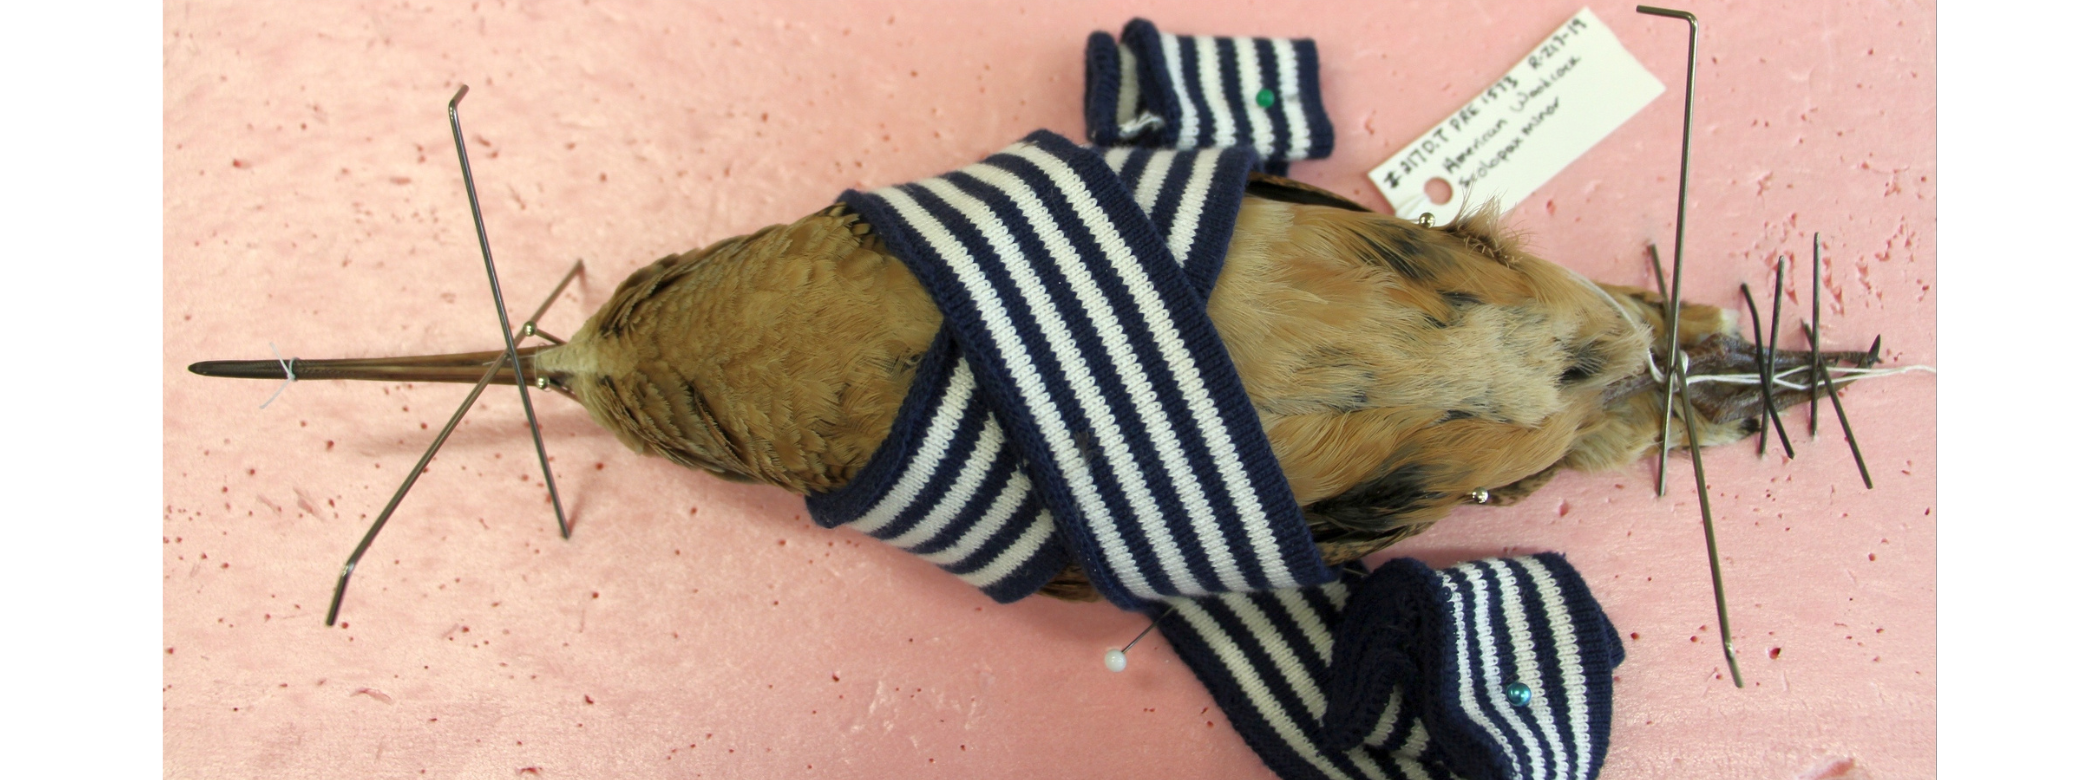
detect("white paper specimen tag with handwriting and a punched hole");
top-left (1371, 8), bottom-right (1663, 225)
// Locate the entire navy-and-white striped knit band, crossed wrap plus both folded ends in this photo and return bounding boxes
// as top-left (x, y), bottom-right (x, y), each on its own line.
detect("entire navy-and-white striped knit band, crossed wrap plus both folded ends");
top-left (809, 19), bottom-right (1623, 780)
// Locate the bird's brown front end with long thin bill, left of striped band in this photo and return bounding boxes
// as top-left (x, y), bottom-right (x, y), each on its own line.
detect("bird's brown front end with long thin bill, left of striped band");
top-left (189, 206), bottom-right (941, 494)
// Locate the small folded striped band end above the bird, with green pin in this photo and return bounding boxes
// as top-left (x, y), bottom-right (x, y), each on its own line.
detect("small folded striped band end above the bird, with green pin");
top-left (1086, 19), bottom-right (1334, 175)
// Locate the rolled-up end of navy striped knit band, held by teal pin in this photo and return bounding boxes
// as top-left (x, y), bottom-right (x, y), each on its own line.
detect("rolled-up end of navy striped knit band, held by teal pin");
top-left (1323, 553), bottom-right (1625, 778)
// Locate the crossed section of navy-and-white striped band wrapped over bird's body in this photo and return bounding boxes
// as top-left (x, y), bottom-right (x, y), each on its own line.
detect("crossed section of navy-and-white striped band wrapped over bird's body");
top-left (809, 130), bottom-right (1334, 612)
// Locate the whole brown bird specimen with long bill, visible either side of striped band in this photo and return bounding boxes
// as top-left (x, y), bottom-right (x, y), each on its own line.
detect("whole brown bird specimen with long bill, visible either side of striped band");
top-left (191, 175), bottom-right (1877, 599)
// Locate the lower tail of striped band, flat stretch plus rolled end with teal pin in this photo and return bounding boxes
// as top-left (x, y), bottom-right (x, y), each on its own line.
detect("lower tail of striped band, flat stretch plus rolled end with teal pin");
top-left (1159, 553), bottom-right (1625, 780)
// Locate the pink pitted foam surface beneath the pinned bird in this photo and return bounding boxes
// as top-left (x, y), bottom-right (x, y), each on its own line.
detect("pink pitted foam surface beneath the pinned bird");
top-left (162, 2), bottom-right (1938, 778)
